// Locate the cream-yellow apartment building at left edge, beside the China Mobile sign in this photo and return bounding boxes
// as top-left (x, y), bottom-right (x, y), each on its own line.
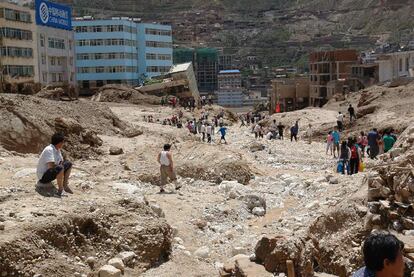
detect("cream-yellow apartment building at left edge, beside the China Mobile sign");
top-left (0, 2), bottom-right (39, 82)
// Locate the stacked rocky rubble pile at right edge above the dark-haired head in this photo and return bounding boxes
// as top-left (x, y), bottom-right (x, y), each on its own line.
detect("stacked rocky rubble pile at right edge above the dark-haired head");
top-left (365, 124), bottom-right (414, 234)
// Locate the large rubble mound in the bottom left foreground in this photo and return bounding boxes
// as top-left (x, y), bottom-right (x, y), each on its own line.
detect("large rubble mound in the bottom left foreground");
top-left (0, 198), bottom-right (172, 276)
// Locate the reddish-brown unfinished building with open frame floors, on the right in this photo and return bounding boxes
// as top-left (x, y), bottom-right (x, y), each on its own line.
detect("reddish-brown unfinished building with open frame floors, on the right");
top-left (309, 49), bottom-right (358, 107)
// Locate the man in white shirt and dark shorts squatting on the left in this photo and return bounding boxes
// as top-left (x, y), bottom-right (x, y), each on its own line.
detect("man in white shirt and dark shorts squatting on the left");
top-left (36, 133), bottom-right (73, 196)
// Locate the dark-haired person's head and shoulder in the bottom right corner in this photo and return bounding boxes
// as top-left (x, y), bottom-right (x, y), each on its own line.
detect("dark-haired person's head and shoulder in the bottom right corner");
top-left (352, 233), bottom-right (405, 277)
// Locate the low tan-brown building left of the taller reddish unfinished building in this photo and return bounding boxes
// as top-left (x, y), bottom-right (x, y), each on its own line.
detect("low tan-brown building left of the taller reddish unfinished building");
top-left (270, 77), bottom-right (309, 114)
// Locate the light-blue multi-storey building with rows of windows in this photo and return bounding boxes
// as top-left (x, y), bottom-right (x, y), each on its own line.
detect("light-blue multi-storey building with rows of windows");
top-left (73, 17), bottom-right (172, 88)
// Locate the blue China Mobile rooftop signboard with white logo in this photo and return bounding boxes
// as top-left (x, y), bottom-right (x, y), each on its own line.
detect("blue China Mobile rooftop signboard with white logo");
top-left (35, 0), bottom-right (72, 30)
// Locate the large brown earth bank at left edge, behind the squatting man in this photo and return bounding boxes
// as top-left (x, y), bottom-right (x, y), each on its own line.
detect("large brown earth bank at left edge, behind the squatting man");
top-left (0, 95), bottom-right (128, 155)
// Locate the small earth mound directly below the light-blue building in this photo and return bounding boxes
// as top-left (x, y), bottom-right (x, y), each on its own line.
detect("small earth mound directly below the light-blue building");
top-left (92, 85), bottom-right (161, 105)
